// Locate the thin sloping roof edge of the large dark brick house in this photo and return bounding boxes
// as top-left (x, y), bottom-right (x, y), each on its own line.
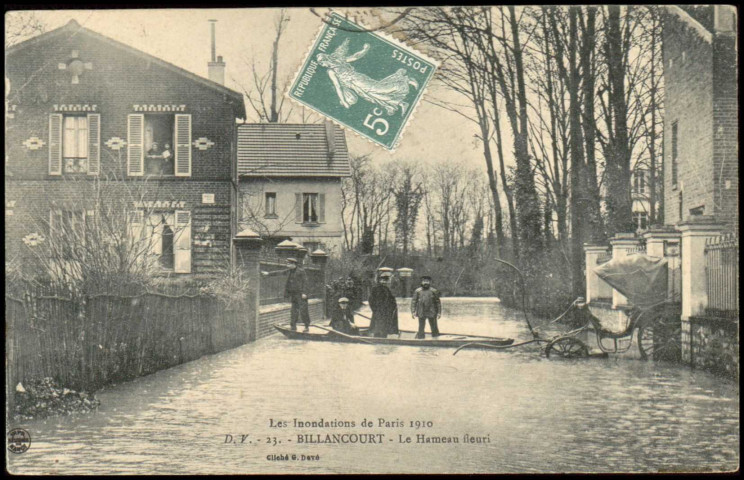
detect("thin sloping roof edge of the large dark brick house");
top-left (5, 19), bottom-right (246, 118)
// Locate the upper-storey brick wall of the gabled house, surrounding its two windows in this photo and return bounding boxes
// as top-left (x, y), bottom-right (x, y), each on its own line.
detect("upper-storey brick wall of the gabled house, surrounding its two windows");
top-left (6, 28), bottom-right (239, 182)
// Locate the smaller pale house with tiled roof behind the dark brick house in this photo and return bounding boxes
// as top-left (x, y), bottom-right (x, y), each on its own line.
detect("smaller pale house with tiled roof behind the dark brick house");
top-left (237, 123), bottom-right (351, 253)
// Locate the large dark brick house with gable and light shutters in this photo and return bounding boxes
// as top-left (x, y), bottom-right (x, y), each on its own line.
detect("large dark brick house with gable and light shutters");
top-left (5, 20), bottom-right (245, 275)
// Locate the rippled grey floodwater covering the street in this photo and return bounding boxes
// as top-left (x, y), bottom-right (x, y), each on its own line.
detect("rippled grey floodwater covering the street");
top-left (8, 298), bottom-right (739, 474)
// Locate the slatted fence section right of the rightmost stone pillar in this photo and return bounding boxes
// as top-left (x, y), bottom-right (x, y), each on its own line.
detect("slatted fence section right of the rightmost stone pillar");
top-left (705, 235), bottom-right (739, 317)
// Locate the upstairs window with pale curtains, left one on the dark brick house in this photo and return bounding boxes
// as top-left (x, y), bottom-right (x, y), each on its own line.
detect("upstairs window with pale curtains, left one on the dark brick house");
top-left (49, 113), bottom-right (101, 175)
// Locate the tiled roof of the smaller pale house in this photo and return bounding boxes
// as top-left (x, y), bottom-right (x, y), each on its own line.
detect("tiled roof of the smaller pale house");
top-left (238, 123), bottom-right (351, 177)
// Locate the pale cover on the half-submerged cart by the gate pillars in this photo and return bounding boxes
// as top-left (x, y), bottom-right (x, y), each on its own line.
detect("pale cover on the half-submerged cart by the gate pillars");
top-left (594, 253), bottom-right (667, 307)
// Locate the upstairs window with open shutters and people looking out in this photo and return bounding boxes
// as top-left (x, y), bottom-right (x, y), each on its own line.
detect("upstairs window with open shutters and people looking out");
top-left (127, 113), bottom-right (191, 177)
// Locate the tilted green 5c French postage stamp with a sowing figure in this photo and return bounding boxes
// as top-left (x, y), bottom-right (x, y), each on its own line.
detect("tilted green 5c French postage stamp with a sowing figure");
top-left (287, 13), bottom-right (437, 150)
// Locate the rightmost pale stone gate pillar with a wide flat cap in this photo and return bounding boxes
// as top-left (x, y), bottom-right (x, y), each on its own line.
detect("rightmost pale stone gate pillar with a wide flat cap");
top-left (677, 215), bottom-right (724, 363)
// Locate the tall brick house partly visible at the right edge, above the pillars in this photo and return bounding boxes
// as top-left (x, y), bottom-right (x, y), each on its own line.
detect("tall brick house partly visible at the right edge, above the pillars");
top-left (663, 5), bottom-right (739, 226)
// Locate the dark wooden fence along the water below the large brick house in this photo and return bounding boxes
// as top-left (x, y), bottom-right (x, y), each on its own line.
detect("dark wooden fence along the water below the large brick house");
top-left (5, 284), bottom-right (255, 390)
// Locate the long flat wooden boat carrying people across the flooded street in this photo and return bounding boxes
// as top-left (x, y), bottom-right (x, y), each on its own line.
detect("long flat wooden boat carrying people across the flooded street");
top-left (274, 325), bottom-right (514, 348)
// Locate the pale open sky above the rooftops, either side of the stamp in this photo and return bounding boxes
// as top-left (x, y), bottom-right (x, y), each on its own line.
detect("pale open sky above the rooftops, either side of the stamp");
top-left (11, 9), bottom-right (492, 173)
